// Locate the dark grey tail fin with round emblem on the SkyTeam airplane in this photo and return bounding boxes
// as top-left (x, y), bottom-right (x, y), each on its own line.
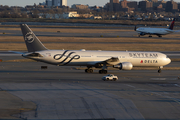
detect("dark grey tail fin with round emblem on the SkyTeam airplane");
top-left (20, 24), bottom-right (47, 52)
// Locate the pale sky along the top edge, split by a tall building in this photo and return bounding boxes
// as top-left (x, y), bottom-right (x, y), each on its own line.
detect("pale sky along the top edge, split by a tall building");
top-left (0, 0), bottom-right (110, 6)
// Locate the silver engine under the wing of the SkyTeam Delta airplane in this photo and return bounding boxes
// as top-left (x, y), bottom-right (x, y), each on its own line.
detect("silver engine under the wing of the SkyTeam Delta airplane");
top-left (113, 62), bottom-right (133, 70)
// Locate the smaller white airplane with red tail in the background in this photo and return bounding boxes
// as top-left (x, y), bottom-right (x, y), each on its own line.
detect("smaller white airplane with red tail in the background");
top-left (134, 18), bottom-right (177, 37)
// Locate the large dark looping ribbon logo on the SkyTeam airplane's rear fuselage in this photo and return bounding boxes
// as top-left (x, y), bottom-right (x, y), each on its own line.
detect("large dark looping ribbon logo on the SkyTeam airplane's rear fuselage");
top-left (54, 50), bottom-right (80, 65)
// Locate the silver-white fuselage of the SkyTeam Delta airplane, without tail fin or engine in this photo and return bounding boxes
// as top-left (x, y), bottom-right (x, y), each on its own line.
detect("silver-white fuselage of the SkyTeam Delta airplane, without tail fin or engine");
top-left (23, 50), bottom-right (171, 67)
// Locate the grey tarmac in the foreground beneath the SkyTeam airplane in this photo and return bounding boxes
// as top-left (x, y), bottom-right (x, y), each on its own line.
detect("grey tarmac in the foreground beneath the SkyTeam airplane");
top-left (0, 62), bottom-right (180, 120)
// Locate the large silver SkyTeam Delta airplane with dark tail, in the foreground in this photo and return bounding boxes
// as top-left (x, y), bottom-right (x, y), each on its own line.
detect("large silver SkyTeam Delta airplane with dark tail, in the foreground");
top-left (20, 24), bottom-right (171, 74)
